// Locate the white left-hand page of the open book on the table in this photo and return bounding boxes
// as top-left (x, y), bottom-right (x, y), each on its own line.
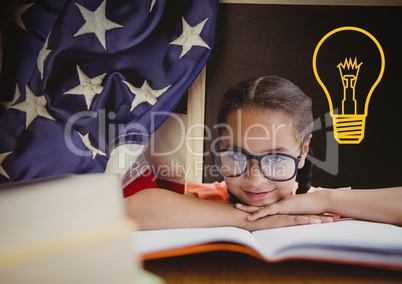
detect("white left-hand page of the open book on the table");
top-left (132, 227), bottom-right (260, 254)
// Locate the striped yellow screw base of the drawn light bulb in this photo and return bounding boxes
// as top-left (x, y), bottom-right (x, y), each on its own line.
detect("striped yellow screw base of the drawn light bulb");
top-left (331, 114), bottom-right (366, 144)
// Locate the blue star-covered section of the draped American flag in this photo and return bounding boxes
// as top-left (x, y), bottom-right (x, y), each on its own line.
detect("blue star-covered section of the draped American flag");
top-left (0, 0), bottom-right (218, 183)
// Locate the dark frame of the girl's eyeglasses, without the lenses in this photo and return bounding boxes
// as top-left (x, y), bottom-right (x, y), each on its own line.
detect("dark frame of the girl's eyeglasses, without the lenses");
top-left (211, 148), bottom-right (302, 182)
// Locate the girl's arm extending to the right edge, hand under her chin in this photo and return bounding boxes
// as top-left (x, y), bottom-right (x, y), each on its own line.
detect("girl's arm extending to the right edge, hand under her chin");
top-left (240, 187), bottom-right (402, 226)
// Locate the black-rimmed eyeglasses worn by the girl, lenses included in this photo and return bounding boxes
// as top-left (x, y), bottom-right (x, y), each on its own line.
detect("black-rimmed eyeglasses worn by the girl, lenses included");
top-left (212, 149), bottom-right (301, 181)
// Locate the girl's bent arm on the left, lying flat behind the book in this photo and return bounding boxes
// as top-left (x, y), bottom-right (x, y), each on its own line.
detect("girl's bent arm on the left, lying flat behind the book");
top-left (125, 188), bottom-right (332, 230)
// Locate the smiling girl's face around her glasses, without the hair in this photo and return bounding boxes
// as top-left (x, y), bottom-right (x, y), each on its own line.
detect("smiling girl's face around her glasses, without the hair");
top-left (220, 108), bottom-right (309, 206)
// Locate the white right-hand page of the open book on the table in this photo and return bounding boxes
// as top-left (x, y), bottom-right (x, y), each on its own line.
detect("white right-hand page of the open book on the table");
top-left (253, 220), bottom-right (402, 265)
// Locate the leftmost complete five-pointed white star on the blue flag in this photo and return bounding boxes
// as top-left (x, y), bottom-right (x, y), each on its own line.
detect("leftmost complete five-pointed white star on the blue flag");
top-left (11, 85), bottom-right (56, 129)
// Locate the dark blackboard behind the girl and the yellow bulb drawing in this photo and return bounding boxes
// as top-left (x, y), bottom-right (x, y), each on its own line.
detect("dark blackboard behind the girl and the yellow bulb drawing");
top-left (204, 4), bottom-right (402, 188)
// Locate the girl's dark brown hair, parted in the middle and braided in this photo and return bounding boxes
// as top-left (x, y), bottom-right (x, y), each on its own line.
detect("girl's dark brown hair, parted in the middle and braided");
top-left (217, 76), bottom-right (313, 193)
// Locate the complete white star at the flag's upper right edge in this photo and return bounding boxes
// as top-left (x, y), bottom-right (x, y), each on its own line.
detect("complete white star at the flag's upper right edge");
top-left (169, 18), bottom-right (211, 58)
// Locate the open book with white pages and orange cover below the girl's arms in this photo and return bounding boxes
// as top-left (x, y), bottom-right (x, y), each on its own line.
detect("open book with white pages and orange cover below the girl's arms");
top-left (132, 220), bottom-right (402, 270)
